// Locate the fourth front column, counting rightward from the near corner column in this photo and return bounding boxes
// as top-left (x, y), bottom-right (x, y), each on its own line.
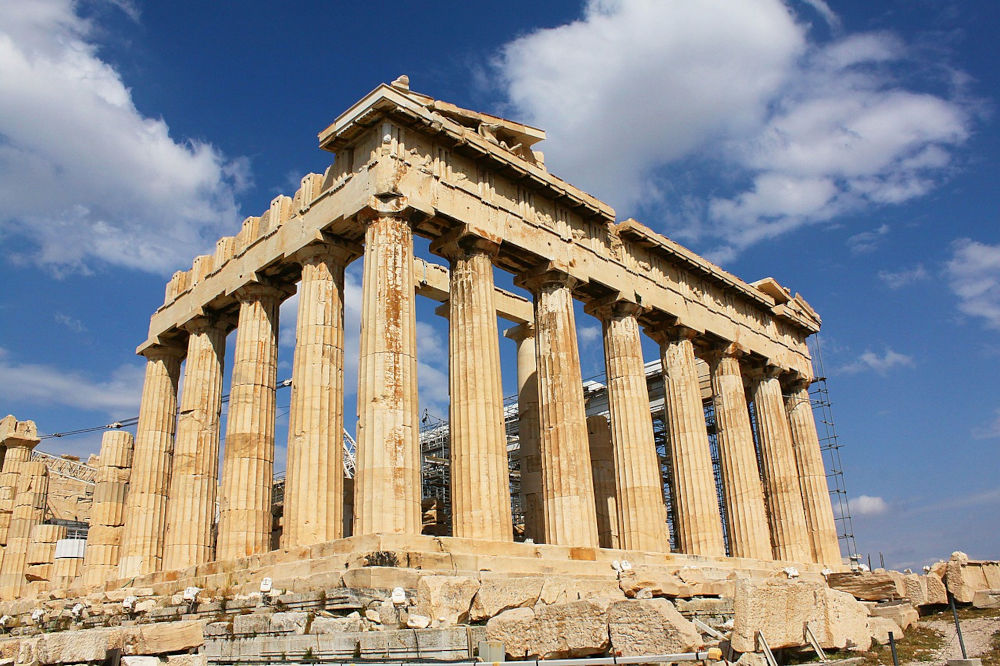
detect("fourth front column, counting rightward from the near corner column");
top-left (594, 301), bottom-right (670, 553)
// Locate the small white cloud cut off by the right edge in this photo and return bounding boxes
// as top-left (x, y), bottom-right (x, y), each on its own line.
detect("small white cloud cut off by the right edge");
top-left (945, 238), bottom-right (1000, 329)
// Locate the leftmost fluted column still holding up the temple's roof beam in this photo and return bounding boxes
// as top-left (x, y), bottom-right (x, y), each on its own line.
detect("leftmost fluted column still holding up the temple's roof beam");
top-left (118, 345), bottom-right (184, 578)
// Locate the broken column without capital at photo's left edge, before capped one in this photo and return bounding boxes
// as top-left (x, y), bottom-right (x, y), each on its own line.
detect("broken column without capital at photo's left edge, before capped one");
top-left (0, 462), bottom-right (49, 601)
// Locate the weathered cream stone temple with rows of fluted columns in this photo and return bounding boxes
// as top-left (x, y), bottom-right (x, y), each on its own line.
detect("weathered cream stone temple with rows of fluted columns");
top-left (0, 77), bottom-right (948, 663)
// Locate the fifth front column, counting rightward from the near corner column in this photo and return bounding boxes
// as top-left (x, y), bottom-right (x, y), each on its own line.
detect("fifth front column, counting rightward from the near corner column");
top-left (654, 328), bottom-right (726, 556)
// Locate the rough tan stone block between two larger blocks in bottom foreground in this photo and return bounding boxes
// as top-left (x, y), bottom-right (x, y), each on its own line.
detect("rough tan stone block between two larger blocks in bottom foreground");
top-left (608, 599), bottom-right (702, 657)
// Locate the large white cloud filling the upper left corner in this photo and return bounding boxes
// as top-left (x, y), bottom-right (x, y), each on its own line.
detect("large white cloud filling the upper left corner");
top-left (0, 0), bottom-right (247, 272)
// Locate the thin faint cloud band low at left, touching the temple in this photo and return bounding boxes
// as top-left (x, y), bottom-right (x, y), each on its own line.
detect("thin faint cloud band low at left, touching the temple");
top-left (0, 349), bottom-right (144, 418)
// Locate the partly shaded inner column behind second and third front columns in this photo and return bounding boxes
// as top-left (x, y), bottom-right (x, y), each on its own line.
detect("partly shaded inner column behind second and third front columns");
top-left (504, 323), bottom-right (545, 543)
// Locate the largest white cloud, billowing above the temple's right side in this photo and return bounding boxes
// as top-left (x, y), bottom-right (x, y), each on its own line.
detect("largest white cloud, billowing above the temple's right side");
top-left (498, 0), bottom-right (970, 258)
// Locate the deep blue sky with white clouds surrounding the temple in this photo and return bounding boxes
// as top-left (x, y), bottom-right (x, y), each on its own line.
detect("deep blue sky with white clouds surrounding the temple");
top-left (0, 0), bottom-right (1000, 568)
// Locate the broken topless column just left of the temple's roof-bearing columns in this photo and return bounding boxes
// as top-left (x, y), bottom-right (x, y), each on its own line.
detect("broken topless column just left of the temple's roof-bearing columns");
top-left (81, 430), bottom-right (136, 587)
